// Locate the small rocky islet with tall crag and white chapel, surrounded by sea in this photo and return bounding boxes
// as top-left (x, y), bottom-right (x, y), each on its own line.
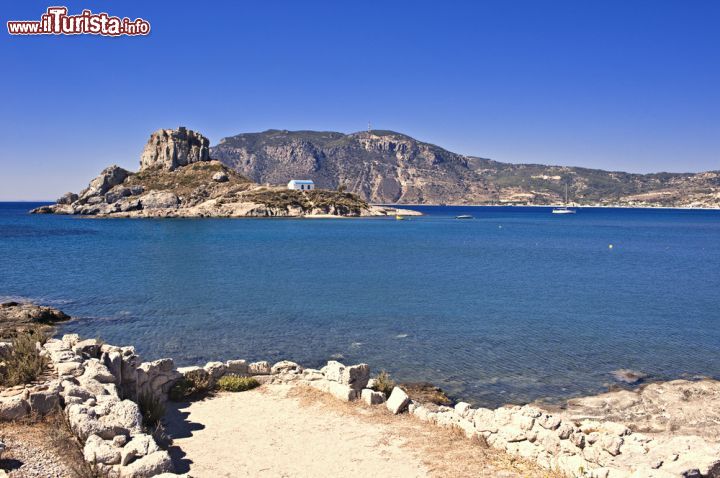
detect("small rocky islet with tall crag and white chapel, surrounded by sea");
top-left (31, 127), bottom-right (419, 217)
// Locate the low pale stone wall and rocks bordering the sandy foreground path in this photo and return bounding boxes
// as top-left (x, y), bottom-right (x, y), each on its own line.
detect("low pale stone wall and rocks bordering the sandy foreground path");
top-left (0, 304), bottom-right (720, 478)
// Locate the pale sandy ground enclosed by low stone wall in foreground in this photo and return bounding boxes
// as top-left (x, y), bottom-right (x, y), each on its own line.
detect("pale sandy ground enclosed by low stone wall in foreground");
top-left (167, 385), bottom-right (546, 478)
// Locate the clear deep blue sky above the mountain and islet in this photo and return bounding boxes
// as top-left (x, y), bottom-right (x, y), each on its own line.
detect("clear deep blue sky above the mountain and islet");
top-left (0, 0), bottom-right (720, 200)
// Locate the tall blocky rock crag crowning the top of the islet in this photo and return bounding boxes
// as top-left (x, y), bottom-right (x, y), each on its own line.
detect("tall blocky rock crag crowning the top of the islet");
top-left (140, 126), bottom-right (210, 171)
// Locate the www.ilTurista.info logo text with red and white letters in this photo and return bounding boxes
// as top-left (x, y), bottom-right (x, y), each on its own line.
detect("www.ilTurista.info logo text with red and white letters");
top-left (7, 7), bottom-right (150, 37)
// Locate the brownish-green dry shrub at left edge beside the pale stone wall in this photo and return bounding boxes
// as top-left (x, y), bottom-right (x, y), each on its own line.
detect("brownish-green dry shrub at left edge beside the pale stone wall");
top-left (0, 328), bottom-right (48, 387)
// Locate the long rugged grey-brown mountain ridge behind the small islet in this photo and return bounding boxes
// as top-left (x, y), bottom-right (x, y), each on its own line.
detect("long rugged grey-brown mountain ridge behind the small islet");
top-left (210, 130), bottom-right (720, 207)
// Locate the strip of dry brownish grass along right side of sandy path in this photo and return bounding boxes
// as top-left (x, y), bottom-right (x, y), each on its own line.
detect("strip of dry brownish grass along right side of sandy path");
top-left (286, 387), bottom-right (562, 478)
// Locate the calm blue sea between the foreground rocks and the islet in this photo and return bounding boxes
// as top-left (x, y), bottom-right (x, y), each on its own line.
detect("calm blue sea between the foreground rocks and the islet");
top-left (0, 203), bottom-right (720, 406)
